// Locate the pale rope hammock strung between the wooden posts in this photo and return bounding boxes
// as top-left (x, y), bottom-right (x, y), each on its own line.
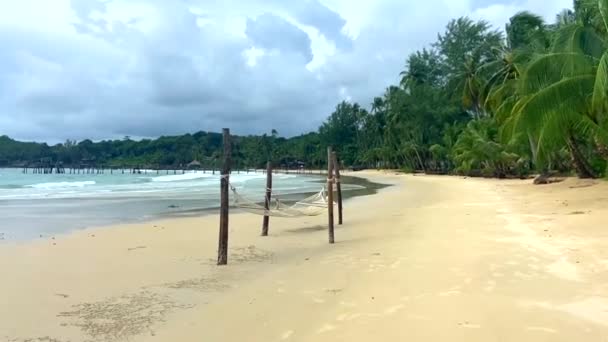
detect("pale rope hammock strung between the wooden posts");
top-left (231, 187), bottom-right (327, 217)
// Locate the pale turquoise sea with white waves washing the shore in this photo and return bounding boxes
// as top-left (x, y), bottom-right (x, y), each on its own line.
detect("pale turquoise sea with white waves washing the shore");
top-left (0, 169), bottom-right (361, 241)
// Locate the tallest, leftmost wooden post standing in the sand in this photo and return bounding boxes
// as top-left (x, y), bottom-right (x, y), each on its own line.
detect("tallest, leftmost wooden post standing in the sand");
top-left (217, 128), bottom-right (232, 265)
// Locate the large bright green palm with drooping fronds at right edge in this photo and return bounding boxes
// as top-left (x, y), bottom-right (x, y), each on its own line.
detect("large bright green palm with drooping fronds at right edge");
top-left (506, 0), bottom-right (608, 177)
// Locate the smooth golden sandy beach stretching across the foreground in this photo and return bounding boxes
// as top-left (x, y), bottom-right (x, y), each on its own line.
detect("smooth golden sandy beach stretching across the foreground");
top-left (0, 171), bottom-right (608, 342)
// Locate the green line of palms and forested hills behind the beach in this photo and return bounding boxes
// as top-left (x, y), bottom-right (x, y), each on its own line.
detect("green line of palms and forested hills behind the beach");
top-left (0, 0), bottom-right (608, 178)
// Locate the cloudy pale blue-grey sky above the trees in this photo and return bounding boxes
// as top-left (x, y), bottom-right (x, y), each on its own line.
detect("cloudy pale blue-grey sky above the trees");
top-left (0, 0), bottom-right (571, 142)
